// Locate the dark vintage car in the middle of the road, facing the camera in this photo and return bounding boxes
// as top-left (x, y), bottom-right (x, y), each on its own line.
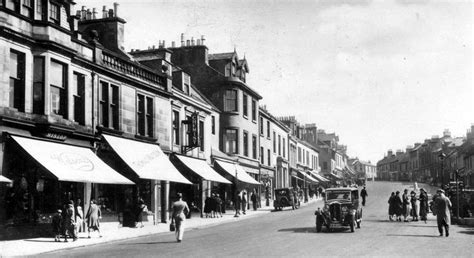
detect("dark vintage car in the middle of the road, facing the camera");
top-left (314, 188), bottom-right (362, 232)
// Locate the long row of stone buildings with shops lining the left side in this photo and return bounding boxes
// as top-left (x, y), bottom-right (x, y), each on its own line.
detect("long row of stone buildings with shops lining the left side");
top-left (0, 0), bottom-right (372, 234)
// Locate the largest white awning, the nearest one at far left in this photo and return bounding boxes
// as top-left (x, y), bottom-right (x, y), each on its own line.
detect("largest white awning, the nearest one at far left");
top-left (12, 136), bottom-right (133, 184)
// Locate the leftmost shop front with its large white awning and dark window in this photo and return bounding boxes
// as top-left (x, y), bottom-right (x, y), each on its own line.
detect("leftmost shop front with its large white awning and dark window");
top-left (3, 135), bottom-right (133, 232)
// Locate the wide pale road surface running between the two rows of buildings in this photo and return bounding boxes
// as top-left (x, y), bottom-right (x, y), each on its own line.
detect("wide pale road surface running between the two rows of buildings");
top-left (47, 182), bottom-right (474, 257)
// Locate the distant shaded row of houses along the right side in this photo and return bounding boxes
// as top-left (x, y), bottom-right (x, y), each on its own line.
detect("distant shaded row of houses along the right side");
top-left (377, 125), bottom-right (474, 187)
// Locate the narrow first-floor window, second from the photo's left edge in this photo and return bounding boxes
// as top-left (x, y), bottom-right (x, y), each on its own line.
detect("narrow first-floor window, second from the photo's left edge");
top-left (33, 56), bottom-right (45, 115)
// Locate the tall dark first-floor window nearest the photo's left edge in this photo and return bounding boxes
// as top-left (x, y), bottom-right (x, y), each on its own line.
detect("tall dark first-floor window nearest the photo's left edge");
top-left (10, 50), bottom-right (25, 112)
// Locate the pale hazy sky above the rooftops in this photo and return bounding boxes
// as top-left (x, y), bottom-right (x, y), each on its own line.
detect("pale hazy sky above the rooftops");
top-left (76, 0), bottom-right (474, 163)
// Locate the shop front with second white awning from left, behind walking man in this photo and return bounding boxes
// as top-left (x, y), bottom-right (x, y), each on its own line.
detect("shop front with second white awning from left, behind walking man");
top-left (97, 134), bottom-right (192, 226)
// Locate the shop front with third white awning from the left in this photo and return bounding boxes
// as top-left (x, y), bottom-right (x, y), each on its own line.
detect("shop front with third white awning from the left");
top-left (170, 154), bottom-right (232, 217)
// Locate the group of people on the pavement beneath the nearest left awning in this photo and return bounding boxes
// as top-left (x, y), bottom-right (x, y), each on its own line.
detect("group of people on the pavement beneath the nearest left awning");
top-left (51, 199), bottom-right (102, 242)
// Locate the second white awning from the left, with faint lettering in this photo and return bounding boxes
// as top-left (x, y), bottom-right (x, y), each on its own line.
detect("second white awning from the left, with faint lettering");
top-left (103, 135), bottom-right (192, 184)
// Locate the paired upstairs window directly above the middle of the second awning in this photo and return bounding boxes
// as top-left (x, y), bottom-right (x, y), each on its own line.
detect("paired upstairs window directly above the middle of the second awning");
top-left (137, 94), bottom-right (154, 137)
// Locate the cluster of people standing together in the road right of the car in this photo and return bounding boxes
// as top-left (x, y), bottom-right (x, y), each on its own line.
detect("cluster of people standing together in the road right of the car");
top-left (388, 188), bottom-right (429, 223)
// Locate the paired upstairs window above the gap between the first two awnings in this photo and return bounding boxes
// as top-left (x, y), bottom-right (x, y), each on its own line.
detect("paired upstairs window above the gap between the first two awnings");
top-left (99, 81), bottom-right (119, 130)
